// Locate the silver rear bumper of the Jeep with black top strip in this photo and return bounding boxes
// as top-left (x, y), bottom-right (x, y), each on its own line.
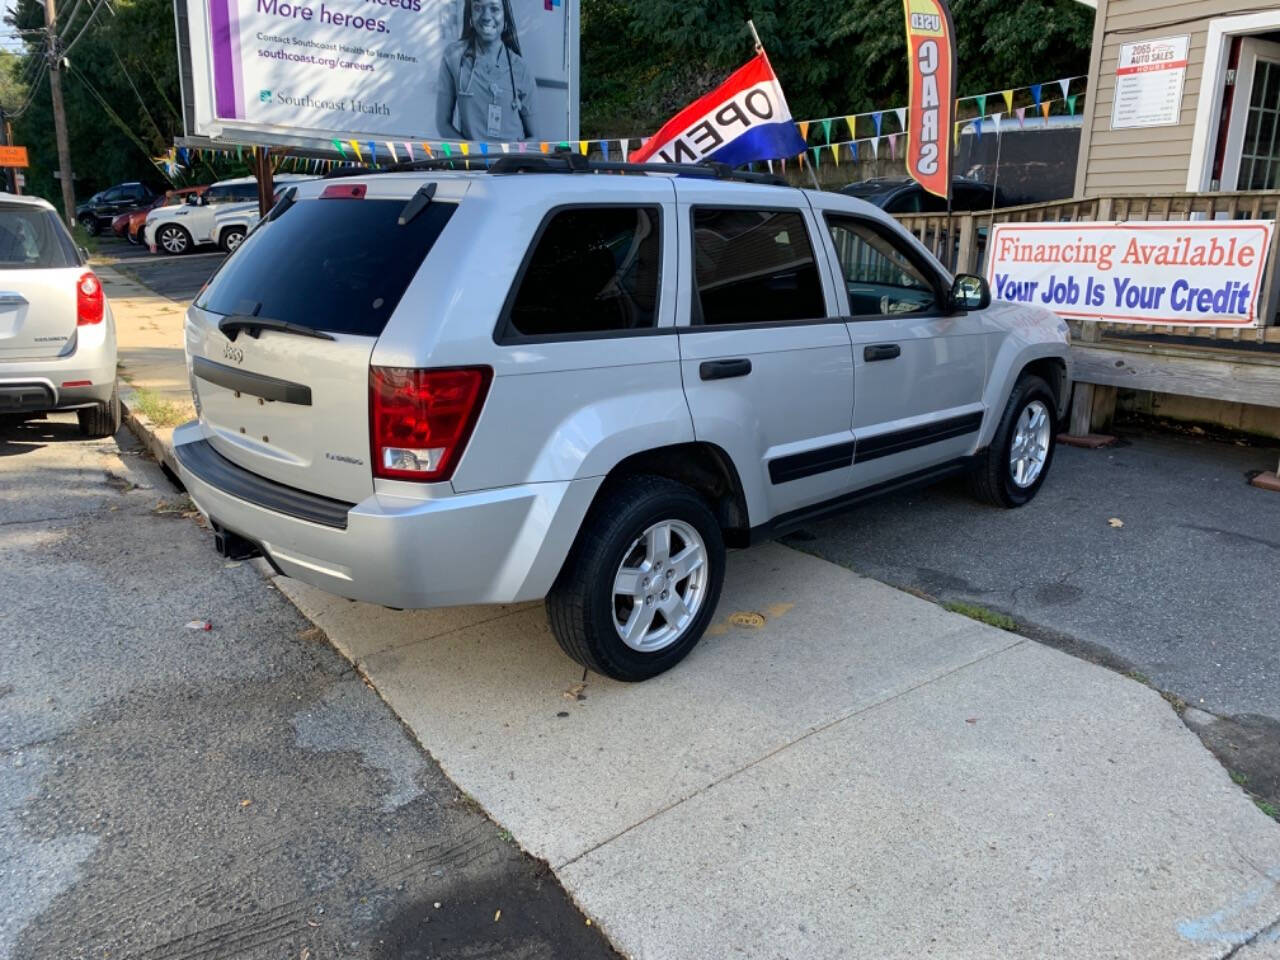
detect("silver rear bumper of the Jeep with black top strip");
top-left (173, 421), bottom-right (602, 608)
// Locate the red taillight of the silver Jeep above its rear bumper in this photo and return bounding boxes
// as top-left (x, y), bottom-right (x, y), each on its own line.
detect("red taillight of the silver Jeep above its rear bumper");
top-left (369, 366), bottom-right (493, 483)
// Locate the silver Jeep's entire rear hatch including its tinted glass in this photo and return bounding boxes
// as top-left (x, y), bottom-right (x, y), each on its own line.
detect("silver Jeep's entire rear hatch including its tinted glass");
top-left (187, 174), bottom-right (466, 503)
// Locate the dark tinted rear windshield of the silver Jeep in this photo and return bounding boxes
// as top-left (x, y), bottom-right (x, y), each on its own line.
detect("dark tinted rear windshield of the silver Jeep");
top-left (196, 200), bottom-right (456, 337)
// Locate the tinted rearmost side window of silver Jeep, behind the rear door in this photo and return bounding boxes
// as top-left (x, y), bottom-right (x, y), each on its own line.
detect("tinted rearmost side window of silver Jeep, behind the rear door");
top-left (507, 206), bottom-right (662, 337)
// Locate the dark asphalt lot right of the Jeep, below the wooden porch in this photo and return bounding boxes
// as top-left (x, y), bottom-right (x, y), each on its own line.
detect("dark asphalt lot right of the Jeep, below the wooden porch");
top-left (788, 434), bottom-right (1280, 730)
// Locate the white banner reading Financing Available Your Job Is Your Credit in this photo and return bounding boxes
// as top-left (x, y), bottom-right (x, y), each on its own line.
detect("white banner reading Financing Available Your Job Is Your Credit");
top-left (987, 220), bottom-right (1275, 326)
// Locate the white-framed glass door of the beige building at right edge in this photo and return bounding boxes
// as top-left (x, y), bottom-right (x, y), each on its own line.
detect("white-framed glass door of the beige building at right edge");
top-left (1222, 37), bottom-right (1280, 189)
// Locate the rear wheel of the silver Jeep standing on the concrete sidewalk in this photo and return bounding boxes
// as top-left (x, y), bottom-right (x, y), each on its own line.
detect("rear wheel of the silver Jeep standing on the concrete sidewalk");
top-left (547, 476), bottom-right (724, 681)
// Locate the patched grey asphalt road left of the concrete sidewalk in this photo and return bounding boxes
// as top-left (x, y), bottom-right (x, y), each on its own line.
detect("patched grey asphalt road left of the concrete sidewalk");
top-left (0, 416), bottom-right (613, 960)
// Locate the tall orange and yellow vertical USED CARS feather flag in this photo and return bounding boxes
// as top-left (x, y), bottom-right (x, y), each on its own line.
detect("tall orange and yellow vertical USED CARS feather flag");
top-left (902, 0), bottom-right (956, 197)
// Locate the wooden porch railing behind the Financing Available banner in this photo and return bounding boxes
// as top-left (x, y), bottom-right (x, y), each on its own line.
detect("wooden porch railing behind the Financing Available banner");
top-left (897, 191), bottom-right (1280, 346)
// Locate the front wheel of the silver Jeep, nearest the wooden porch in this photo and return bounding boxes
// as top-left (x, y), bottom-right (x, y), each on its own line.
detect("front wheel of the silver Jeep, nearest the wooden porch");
top-left (969, 374), bottom-right (1057, 508)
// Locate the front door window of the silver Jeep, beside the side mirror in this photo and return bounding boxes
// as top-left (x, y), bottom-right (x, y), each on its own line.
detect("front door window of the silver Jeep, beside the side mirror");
top-left (827, 216), bottom-right (938, 316)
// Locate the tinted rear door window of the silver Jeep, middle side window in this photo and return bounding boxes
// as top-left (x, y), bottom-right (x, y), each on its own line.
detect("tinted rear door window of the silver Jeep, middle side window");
top-left (694, 207), bottom-right (827, 325)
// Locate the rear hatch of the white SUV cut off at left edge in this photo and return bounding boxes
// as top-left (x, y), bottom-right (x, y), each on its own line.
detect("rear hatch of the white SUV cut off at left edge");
top-left (0, 201), bottom-right (86, 362)
